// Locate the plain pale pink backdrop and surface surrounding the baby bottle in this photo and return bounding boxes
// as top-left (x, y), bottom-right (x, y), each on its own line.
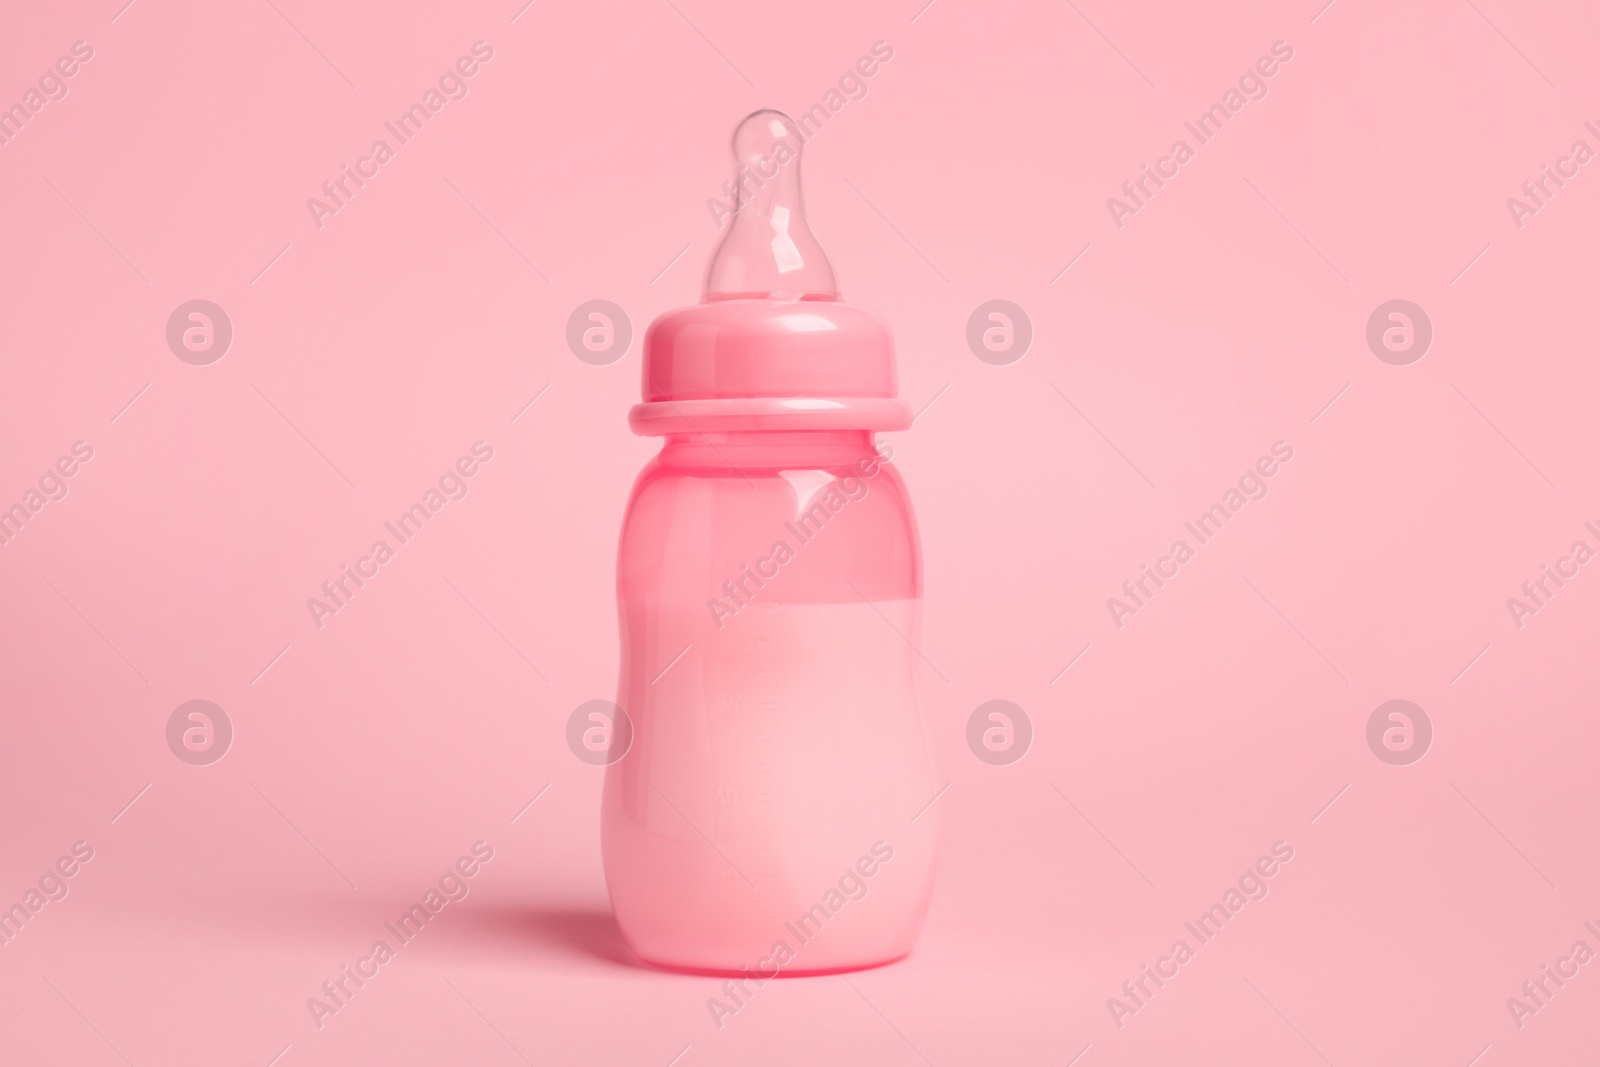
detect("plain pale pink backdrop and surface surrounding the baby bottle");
top-left (0, 0), bottom-right (1600, 1067)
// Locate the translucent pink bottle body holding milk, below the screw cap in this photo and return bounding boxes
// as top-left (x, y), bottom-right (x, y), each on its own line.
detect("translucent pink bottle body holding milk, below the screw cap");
top-left (602, 430), bottom-right (938, 976)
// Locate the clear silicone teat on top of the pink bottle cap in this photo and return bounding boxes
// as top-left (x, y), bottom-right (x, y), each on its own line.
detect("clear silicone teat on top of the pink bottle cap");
top-left (704, 110), bottom-right (838, 301)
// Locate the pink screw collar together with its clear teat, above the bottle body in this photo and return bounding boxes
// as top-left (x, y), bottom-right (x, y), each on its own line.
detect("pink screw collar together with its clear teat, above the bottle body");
top-left (629, 110), bottom-right (910, 435)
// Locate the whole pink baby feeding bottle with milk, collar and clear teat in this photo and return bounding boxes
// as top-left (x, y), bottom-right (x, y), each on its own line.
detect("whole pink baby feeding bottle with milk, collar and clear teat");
top-left (602, 110), bottom-right (938, 979)
